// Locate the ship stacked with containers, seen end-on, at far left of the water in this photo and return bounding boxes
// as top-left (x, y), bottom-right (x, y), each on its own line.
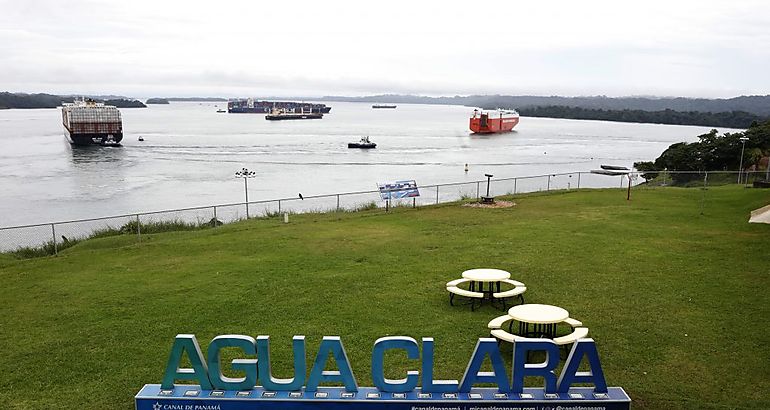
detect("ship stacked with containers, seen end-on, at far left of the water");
top-left (61, 100), bottom-right (123, 145)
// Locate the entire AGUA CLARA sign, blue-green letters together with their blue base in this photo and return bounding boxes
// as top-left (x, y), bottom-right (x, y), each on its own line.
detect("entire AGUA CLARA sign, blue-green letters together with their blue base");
top-left (136, 334), bottom-right (631, 410)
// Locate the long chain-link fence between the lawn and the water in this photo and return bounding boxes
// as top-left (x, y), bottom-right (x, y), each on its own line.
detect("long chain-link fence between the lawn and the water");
top-left (0, 170), bottom-right (766, 257)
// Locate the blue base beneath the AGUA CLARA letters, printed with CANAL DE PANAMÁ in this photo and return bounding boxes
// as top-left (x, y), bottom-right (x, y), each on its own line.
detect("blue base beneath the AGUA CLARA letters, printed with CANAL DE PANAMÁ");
top-left (136, 384), bottom-right (631, 410)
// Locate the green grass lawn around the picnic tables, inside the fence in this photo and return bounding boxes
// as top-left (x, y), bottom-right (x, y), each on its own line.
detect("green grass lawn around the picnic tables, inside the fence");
top-left (0, 186), bottom-right (770, 409)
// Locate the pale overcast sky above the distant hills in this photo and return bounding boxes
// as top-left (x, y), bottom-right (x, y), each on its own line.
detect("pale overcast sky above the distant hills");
top-left (0, 0), bottom-right (770, 97)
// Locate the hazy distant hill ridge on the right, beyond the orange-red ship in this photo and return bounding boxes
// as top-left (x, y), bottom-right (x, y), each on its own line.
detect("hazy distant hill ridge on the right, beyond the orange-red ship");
top-left (321, 94), bottom-right (770, 117)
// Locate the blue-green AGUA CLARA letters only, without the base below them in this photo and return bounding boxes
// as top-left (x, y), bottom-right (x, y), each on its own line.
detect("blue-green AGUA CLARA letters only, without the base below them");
top-left (160, 334), bottom-right (607, 394)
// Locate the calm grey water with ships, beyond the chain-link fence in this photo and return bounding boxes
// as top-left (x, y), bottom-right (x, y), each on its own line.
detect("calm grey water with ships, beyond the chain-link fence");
top-left (0, 103), bottom-right (728, 226)
